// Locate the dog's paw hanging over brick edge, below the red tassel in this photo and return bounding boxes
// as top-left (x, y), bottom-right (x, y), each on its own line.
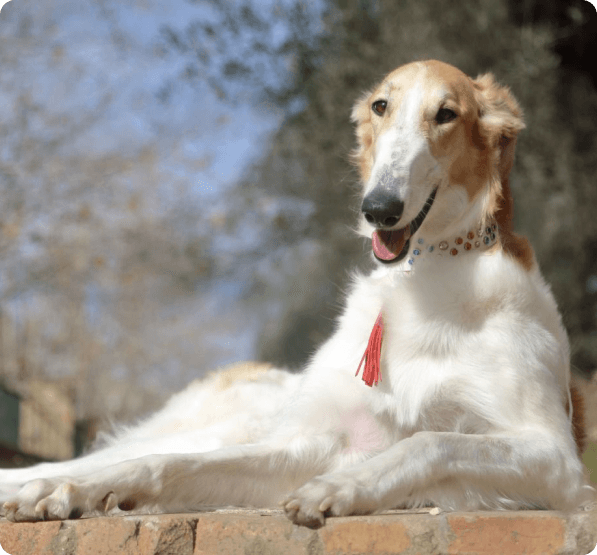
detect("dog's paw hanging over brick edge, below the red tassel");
top-left (281, 474), bottom-right (375, 528)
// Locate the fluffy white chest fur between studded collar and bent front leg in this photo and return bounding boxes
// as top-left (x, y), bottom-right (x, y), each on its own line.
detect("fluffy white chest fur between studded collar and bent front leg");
top-left (318, 250), bottom-right (568, 435)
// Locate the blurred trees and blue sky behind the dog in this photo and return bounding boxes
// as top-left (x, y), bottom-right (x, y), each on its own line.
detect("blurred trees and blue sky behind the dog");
top-left (0, 0), bottom-right (597, 466)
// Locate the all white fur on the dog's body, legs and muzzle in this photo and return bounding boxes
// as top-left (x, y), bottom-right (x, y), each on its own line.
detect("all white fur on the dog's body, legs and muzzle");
top-left (0, 63), bottom-right (594, 525)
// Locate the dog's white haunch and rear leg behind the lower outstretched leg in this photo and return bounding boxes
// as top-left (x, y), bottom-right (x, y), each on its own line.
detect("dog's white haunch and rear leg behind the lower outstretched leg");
top-left (0, 365), bottom-right (300, 514)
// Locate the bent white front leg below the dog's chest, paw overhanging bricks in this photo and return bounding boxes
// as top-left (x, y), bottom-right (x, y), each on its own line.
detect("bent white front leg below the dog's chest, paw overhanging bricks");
top-left (283, 430), bottom-right (595, 525)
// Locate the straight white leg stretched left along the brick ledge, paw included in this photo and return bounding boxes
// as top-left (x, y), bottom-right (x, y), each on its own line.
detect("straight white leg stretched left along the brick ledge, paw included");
top-left (4, 441), bottom-right (330, 521)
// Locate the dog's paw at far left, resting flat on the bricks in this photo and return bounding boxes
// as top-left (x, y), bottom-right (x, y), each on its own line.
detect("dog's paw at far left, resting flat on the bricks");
top-left (3, 479), bottom-right (134, 522)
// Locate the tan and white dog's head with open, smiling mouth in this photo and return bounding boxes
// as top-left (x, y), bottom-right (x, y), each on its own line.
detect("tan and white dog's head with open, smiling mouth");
top-left (352, 61), bottom-right (524, 262)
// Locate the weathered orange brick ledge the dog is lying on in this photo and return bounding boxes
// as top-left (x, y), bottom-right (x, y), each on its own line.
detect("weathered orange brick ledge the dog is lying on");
top-left (0, 508), bottom-right (597, 555)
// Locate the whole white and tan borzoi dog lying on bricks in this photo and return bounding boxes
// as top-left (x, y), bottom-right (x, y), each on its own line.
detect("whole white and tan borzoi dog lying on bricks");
top-left (0, 61), bottom-right (594, 526)
